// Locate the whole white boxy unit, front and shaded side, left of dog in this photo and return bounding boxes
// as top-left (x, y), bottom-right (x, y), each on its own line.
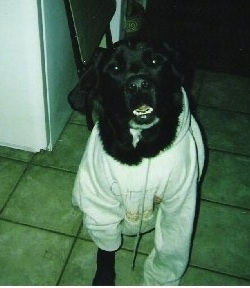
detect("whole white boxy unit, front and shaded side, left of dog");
top-left (0, 0), bottom-right (78, 152)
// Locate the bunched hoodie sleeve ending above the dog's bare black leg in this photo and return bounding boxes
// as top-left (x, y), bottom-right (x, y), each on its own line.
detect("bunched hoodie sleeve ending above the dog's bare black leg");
top-left (72, 126), bottom-right (124, 251)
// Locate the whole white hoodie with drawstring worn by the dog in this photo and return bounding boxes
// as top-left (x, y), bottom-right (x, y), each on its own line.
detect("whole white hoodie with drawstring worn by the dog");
top-left (73, 89), bottom-right (204, 285)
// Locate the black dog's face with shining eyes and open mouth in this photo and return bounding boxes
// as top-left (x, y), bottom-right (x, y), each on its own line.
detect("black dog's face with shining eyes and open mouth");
top-left (98, 40), bottom-right (181, 130)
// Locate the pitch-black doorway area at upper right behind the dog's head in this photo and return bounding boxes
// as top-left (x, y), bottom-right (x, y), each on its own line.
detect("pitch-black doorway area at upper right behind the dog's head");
top-left (142, 0), bottom-right (250, 75)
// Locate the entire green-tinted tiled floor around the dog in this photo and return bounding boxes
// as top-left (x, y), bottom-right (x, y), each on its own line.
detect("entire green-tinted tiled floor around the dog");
top-left (0, 71), bottom-right (250, 285)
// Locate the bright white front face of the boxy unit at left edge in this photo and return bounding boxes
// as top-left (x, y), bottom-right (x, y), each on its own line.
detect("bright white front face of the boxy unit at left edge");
top-left (0, 0), bottom-right (47, 151)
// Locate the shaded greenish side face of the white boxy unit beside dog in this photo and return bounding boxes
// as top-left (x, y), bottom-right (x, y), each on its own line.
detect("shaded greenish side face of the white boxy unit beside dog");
top-left (41, 0), bottom-right (78, 150)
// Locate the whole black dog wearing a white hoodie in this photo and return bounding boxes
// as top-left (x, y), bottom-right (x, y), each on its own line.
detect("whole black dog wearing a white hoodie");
top-left (69, 40), bottom-right (204, 285)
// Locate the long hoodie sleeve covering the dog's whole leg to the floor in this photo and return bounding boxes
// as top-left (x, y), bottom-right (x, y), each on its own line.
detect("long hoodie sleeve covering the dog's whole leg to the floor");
top-left (144, 130), bottom-right (198, 285)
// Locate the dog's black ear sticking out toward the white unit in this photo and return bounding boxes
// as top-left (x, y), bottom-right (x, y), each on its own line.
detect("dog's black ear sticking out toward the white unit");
top-left (68, 50), bottom-right (102, 114)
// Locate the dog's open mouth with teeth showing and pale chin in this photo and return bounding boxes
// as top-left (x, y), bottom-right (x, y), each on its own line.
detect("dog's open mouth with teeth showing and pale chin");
top-left (130, 104), bottom-right (159, 129)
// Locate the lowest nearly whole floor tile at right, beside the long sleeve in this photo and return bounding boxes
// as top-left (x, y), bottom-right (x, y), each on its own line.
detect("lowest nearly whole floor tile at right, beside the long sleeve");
top-left (191, 201), bottom-right (250, 279)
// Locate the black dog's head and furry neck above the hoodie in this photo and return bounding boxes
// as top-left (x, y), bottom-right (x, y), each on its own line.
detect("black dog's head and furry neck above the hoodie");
top-left (70, 39), bottom-right (189, 164)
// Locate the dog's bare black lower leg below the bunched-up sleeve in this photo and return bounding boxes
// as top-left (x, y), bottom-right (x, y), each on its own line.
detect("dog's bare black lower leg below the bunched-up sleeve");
top-left (92, 248), bottom-right (115, 286)
